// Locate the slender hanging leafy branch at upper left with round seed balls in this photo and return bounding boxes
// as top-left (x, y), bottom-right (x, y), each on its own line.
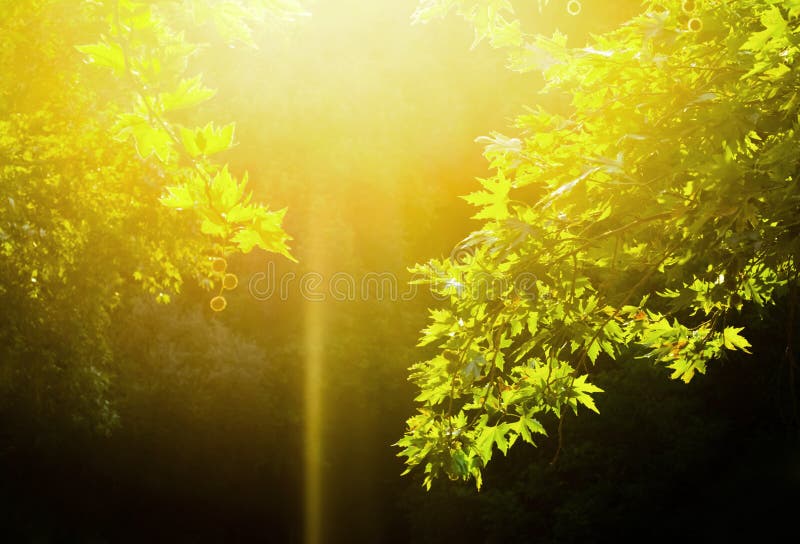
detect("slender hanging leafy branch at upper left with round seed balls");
top-left (77, 0), bottom-right (299, 302)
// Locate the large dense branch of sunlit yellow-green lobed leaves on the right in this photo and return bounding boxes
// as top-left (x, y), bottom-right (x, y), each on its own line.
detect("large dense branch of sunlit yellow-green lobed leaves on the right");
top-left (398, 0), bottom-right (800, 488)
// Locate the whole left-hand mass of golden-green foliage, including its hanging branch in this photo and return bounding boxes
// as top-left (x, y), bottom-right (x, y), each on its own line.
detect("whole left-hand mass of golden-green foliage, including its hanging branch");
top-left (0, 0), bottom-right (304, 432)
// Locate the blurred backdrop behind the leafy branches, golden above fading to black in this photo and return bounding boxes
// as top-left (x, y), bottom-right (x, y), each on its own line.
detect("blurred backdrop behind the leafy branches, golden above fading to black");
top-left (0, 0), bottom-right (800, 542)
